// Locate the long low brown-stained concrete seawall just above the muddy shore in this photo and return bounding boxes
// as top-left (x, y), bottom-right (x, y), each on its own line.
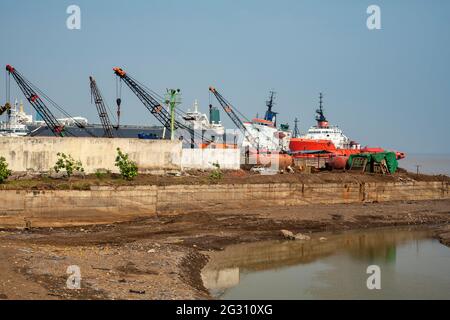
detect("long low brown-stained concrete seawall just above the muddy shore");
top-left (0, 181), bottom-right (449, 227)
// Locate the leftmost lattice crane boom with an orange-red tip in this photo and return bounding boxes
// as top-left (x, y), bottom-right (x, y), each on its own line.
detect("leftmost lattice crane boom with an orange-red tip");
top-left (6, 65), bottom-right (65, 137)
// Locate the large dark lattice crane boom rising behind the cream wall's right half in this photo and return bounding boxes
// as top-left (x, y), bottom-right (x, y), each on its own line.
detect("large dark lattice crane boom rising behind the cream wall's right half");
top-left (113, 68), bottom-right (205, 145)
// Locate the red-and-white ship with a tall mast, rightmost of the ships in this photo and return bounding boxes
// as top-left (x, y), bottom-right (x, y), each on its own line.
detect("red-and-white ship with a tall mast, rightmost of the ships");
top-left (289, 93), bottom-right (405, 159)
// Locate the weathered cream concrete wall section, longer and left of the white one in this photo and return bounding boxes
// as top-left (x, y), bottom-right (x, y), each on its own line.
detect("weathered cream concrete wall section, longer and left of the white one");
top-left (0, 137), bottom-right (181, 173)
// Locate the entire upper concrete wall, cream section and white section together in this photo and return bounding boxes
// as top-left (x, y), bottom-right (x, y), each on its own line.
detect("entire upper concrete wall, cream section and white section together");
top-left (0, 137), bottom-right (240, 174)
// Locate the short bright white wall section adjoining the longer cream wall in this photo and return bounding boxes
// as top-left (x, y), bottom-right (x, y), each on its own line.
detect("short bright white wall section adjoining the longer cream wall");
top-left (181, 149), bottom-right (241, 170)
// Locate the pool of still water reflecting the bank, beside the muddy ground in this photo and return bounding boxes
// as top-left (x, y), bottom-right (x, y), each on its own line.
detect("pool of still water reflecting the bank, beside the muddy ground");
top-left (202, 229), bottom-right (450, 299)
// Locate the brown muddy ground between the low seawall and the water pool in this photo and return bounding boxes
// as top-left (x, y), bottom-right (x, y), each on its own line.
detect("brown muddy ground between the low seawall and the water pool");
top-left (0, 200), bottom-right (450, 299)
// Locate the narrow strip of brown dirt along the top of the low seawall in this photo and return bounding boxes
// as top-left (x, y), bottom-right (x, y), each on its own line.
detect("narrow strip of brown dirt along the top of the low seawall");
top-left (4, 170), bottom-right (450, 190)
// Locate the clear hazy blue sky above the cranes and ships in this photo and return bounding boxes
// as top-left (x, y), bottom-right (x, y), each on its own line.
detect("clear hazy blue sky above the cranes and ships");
top-left (0, 0), bottom-right (450, 154)
